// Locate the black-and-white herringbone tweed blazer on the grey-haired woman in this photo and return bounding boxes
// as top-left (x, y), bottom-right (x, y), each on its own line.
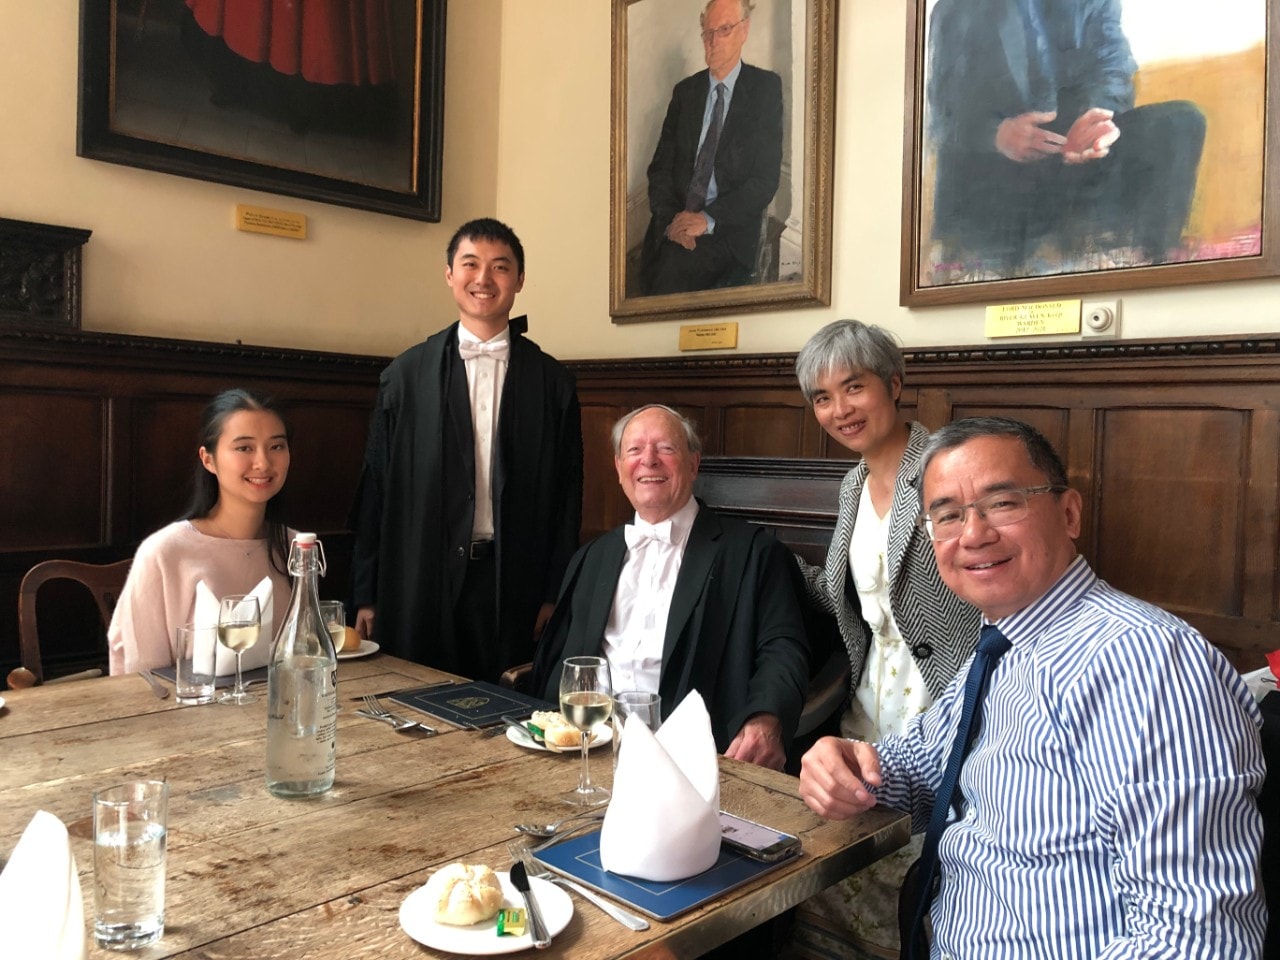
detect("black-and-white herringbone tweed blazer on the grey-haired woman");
top-left (800, 421), bottom-right (982, 699)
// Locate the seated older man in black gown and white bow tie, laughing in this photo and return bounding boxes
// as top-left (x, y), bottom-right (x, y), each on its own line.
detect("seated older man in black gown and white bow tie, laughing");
top-left (531, 404), bottom-right (809, 769)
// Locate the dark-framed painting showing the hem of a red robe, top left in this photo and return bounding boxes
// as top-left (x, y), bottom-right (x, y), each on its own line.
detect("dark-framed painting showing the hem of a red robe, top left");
top-left (76, 0), bottom-right (445, 221)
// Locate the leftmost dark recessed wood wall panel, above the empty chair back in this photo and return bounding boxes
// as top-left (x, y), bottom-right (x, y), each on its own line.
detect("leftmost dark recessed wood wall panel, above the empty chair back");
top-left (0, 389), bottom-right (106, 550)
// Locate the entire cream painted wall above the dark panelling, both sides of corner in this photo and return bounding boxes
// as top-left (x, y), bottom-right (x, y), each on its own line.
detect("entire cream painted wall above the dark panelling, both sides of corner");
top-left (0, 0), bottom-right (1280, 358)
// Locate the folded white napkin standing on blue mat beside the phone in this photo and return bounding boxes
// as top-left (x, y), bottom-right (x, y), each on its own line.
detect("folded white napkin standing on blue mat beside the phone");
top-left (600, 690), bottom-right (721, 882)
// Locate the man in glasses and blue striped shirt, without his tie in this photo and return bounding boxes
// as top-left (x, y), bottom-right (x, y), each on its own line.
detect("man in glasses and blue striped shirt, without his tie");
top-left (800, 417), bottom-right (1266, 960)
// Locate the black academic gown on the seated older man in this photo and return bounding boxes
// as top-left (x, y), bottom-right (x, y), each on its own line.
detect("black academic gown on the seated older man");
top-left (532, 503), bottom-right (809, 753)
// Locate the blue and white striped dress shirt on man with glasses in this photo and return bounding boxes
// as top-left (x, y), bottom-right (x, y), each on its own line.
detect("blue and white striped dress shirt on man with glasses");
top-left (876, 557), bottom-right (1266, 960)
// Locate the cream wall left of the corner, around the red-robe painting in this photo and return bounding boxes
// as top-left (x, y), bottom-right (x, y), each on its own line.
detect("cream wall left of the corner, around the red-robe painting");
top-left (0, 0), bottom-right (502, 355)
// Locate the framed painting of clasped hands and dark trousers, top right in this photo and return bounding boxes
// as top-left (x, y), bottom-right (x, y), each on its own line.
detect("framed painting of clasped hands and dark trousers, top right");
top-left (900, 0), bottom-right (1280, 306)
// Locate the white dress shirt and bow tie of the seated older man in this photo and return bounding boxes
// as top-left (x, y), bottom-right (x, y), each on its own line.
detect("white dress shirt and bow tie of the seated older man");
top-left (603, 497), bottom-right (698, 694)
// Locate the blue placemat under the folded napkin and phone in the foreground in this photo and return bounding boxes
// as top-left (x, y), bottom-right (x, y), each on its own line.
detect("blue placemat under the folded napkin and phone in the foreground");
top-left (536, 831), bottom-right (795, 920)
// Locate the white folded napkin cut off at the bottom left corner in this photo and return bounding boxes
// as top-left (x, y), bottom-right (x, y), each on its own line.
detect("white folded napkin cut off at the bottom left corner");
top-left (0, 810), bottom-right (88, 960)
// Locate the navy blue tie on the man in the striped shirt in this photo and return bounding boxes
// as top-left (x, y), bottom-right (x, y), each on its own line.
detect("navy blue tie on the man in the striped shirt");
top-left (902, 623), bottom-right (1010, 960)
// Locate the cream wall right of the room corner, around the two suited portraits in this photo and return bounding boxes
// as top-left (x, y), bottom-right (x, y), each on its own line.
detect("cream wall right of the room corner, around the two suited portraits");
top-left (498, 0), bottom-right (1280, 358)
